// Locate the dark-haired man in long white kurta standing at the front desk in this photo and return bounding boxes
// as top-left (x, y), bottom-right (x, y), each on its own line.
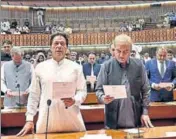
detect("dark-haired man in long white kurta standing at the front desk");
top-left (17, 33), bottom-right (87, 136)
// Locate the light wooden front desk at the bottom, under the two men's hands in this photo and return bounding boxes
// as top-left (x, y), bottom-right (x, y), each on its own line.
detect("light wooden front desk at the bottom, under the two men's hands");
top-left (1, 126), bottom-right (176, 139)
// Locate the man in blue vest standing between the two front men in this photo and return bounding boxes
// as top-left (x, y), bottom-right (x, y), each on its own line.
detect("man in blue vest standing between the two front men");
top-left (83, 52), bottom-right (101, 92)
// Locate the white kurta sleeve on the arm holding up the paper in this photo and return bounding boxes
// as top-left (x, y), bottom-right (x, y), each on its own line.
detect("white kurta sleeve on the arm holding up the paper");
top-left (74, 68), bottom-right (87, 106)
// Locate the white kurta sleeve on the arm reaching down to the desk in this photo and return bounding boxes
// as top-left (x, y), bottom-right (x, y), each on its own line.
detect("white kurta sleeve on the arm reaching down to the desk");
top-left (26, 67), bottom-right (41, 121)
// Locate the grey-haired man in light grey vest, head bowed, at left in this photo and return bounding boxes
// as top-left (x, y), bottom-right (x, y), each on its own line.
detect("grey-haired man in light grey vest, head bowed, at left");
top-left (1, 47), bottom-right (34, 108)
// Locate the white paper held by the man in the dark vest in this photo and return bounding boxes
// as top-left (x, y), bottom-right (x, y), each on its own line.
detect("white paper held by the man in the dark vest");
top-left (103, 85), bottom-right (127, 99)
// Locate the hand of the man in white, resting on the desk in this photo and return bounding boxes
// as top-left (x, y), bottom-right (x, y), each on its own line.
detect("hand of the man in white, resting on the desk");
top-left (16, 121), bottom-right (34, 136)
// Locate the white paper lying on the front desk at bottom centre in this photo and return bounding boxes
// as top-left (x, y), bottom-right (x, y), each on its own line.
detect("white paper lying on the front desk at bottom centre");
top-left (80, 134), bottom-right (112, 139)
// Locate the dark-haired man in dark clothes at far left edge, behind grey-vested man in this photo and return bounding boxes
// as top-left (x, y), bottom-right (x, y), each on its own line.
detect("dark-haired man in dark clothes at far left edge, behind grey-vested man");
top-left (1, 40), bottom-right (13, 61)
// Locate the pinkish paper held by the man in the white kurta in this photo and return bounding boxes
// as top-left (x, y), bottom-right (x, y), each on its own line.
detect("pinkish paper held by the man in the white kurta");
top-left (53, 82), bottom-right (76, 99)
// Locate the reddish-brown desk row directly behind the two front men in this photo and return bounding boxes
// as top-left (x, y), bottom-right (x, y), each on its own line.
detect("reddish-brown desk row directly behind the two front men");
top-left (1, 102), bottom-right (176, 128)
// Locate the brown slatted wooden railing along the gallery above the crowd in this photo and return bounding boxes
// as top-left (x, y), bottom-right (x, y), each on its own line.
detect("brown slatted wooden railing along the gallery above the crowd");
top-left (0, 28), bottom-right (176, 46)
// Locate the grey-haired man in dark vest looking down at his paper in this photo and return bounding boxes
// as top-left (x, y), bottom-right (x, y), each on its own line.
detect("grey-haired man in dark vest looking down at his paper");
top-left (96, 34), bottom-right (153, 129)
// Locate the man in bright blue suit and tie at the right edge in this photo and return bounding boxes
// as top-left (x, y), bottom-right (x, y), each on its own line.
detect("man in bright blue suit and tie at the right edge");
top-left (145, 47), bottom-right (176, 101)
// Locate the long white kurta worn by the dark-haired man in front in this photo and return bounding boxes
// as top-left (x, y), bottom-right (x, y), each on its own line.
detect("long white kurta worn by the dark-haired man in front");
top-left (26, 59), bottom-right (87, 133)
